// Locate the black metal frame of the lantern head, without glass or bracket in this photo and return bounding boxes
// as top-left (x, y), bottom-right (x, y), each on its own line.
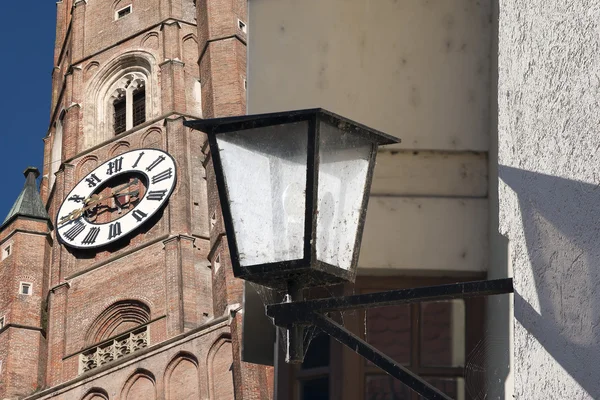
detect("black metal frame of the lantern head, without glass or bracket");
top-left (184, 108), bottom-right (400, 290)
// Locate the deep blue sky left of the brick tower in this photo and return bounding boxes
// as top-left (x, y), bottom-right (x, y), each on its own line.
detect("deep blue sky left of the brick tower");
top-left (0, 0), bottom-right (56, 222)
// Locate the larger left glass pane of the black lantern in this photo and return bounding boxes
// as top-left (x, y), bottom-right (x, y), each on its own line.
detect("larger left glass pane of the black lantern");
top-left (217, 121), bottom-right (308, 266)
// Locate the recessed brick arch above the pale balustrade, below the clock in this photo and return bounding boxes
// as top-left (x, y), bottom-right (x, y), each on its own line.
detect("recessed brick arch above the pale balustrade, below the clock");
top-left (85, 300), bottom-right (150, 347)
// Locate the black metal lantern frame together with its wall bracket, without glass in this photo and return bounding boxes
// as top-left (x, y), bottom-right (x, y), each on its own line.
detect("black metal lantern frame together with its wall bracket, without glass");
top-left (184, 108), bottom-right (514, 400)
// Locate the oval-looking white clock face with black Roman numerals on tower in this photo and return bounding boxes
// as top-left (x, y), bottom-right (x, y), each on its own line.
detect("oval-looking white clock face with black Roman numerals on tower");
top-left (56, 149), bottom-right (177, 249)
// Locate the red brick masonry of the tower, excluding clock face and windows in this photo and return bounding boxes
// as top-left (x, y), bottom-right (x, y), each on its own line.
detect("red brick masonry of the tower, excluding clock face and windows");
top-left (0, 0), bottom-right (272, 400)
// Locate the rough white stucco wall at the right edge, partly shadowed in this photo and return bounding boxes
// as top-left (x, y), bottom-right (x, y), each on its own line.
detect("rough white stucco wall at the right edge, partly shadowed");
top-left (498, 0), bottom-right (600, 400)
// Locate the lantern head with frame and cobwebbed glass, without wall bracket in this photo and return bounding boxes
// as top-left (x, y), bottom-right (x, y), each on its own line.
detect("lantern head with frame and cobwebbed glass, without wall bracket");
top-left (187, 109), bottom-right (400, 290)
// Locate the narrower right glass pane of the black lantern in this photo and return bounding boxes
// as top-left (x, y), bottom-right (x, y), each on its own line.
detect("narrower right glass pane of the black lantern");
top-left (316, 122), bottom-right (373, 270)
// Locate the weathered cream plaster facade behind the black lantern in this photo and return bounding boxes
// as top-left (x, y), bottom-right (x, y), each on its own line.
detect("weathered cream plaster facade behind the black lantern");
top-left (248, 0), bottom-right (512, 400)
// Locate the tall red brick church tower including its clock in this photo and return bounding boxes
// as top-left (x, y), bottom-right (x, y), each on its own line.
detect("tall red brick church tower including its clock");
top-left (0, 0), bottom-right (273, 400)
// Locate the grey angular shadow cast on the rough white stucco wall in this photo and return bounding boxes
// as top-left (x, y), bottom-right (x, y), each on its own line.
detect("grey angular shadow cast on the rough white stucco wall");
top-left (499, 166), bottom-right (600, 399)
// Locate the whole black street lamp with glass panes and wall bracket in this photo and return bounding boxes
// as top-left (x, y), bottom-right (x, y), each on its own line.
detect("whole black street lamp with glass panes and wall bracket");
top-left (185, 109), bottom-right (513, 400)
